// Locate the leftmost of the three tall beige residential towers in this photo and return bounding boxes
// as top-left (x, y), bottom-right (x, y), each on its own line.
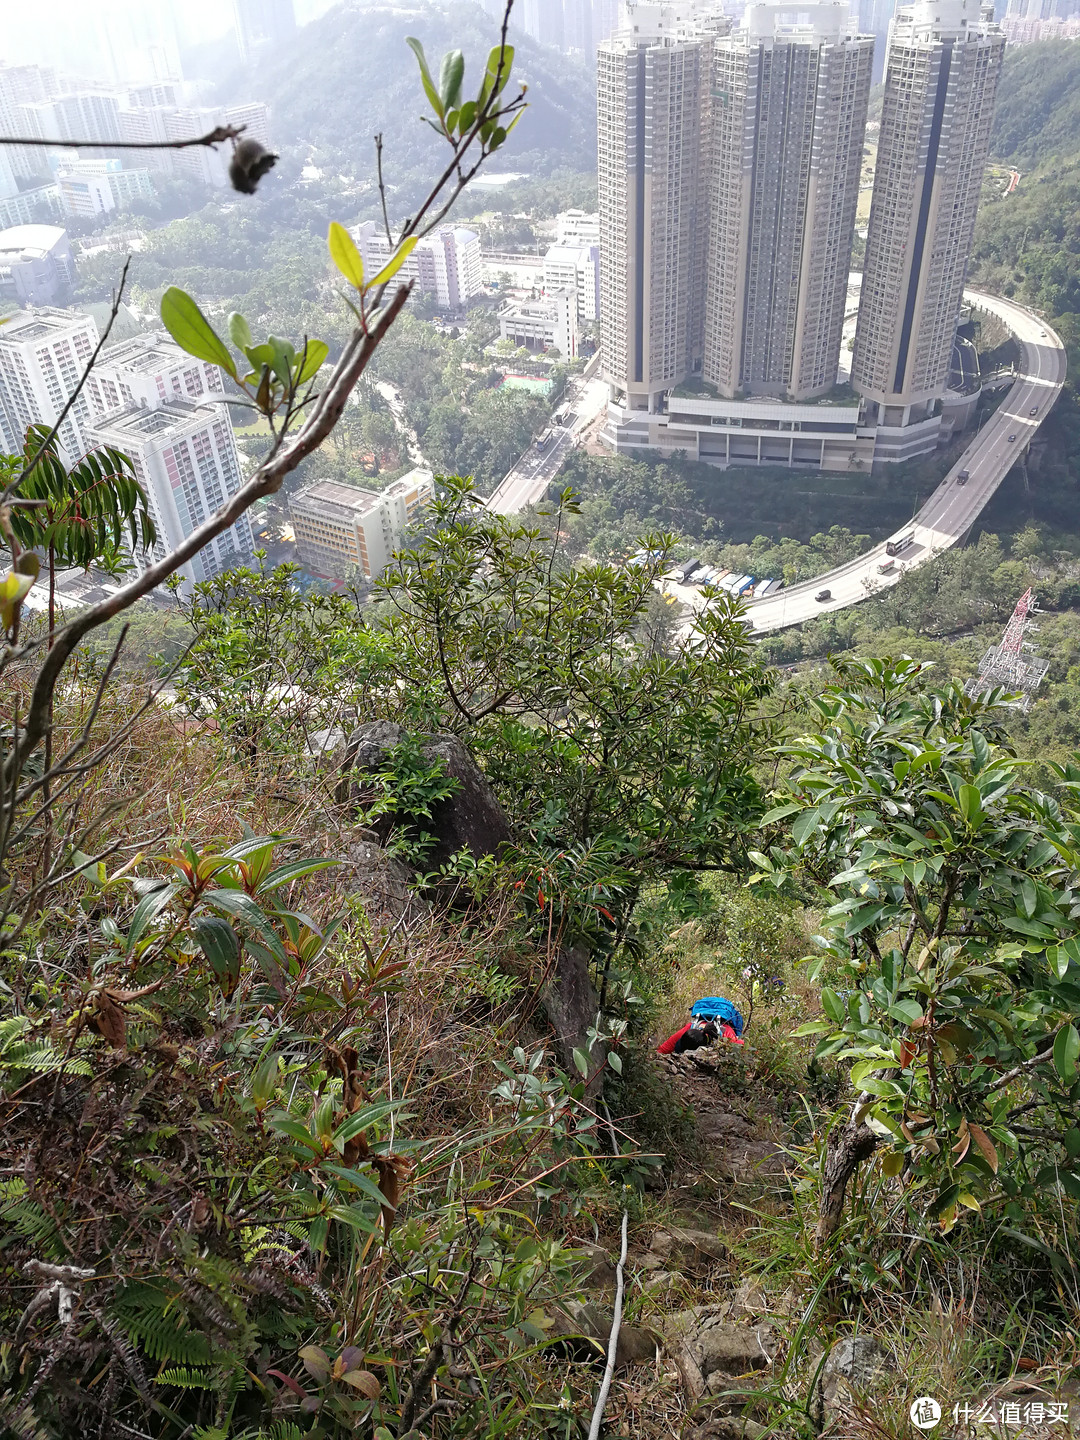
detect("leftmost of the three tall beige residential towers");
top-left (596, 0), bottom-right (729, 412)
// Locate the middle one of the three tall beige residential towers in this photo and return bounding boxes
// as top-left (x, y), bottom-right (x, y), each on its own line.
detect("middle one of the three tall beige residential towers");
top-left (704, 0), bottom-right (874, 402)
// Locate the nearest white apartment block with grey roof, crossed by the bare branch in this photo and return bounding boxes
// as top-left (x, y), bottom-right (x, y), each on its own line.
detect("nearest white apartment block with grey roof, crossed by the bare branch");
top-left (89, 399), bottom-right (255, 592)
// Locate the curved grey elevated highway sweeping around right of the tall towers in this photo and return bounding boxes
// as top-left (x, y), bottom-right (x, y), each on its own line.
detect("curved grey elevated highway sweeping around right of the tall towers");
top-left (746, 289), bottom-right (1066, 634)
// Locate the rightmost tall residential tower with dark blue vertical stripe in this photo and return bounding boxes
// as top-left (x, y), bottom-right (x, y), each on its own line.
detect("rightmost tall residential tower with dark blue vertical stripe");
top-left (851, 0), bottom-right (1005, 461)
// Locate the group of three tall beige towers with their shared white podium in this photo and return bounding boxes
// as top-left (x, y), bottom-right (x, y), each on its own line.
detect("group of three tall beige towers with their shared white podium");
top-left (596, 0), bottom-right (1005, 469)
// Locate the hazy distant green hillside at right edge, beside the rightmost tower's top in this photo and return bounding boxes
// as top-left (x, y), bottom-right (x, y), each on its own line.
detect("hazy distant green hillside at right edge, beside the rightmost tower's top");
top-left (991, 40), bottom-right (1080, 170)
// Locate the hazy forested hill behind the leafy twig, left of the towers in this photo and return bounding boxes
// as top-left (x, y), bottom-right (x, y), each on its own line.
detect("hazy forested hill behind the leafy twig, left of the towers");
top-left (240, 0), bottom-right (596, 204)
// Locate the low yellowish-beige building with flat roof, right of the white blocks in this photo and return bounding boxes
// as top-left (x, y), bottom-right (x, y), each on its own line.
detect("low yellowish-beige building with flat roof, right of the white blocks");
top-left (289, 469), bottom-right (435, 580)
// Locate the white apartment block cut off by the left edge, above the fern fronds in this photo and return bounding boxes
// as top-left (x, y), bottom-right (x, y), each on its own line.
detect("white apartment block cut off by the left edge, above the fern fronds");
top-left (0, 308), bottom-right (98, 465)
